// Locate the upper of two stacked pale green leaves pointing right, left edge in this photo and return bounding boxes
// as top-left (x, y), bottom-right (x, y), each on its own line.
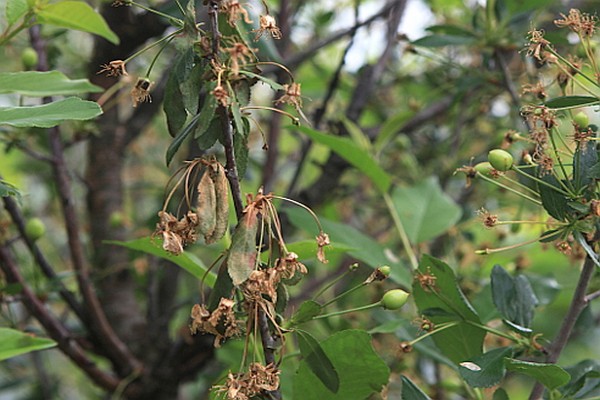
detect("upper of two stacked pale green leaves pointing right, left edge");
top-left (0, 71), bottom-right (104, 97)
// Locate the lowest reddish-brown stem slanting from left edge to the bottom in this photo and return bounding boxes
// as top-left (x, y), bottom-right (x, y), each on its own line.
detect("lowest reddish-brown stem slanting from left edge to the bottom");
top-left (0, 246), bottom-right (139, 397)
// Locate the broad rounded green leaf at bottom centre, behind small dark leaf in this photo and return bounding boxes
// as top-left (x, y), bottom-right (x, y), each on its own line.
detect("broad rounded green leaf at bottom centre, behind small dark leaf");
top-left (292, 330), bottom-right (390, 400)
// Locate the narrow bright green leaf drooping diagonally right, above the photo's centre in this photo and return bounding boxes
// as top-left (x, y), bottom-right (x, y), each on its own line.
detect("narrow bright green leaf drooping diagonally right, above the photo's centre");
top-left (296, 126), bottom-right (392, 193)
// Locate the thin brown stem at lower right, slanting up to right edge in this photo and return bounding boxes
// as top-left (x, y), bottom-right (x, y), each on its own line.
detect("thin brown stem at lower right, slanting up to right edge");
top-left (529, 256), bottom-right (596, 400)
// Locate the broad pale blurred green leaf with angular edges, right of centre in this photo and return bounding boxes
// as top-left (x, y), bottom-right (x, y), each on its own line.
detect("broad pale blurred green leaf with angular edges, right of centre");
top-left (392, 177), bottom-right (462, 244)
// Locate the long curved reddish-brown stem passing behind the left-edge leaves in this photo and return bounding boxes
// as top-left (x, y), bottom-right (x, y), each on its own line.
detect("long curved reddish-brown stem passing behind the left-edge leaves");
top-left (30, 26), bottom-right (142, 375)
